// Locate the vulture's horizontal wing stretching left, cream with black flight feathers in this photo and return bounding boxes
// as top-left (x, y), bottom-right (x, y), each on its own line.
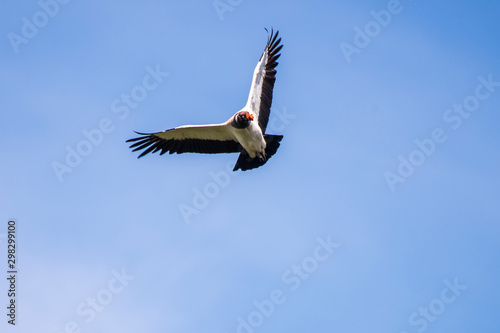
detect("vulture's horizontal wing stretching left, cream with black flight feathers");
top-left (127, 124), bottom-right (241, 158)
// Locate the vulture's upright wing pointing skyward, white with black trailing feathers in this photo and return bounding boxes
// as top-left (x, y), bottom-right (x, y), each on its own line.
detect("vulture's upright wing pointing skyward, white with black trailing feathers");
top-left (244, 30), bottom-right (283, 133)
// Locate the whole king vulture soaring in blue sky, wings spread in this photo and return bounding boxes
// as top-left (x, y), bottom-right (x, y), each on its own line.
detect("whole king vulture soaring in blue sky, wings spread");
top-left (127, 29), bottom-right (283, 171)
